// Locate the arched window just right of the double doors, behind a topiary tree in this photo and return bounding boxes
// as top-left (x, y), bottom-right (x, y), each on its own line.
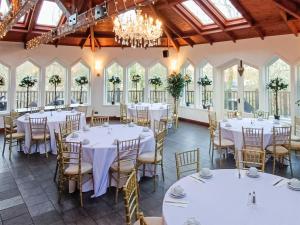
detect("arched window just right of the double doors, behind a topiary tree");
top-left (267, 59), bottom-right (291, 117)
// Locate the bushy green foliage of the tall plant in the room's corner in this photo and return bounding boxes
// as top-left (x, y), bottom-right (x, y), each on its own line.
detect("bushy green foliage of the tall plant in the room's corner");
top-left (167, 72), bottom-right (185, 100)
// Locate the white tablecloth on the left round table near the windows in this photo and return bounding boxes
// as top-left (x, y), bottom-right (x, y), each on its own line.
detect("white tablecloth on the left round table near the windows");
top-left (17, 111), bottom-right (86, 154)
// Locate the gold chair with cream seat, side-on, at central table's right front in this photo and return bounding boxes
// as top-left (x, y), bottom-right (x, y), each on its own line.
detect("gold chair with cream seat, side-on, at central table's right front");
top-left (137, 129), bottom-right (167, 191)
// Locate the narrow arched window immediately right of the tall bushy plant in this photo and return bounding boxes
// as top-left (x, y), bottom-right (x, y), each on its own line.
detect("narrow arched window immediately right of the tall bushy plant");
top-left (181, 63), bottom-right (195, 106)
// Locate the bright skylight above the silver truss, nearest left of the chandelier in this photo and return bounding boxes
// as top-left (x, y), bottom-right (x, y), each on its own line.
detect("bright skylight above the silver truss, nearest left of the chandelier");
top-left (36, 1), bottom-right (62, 27)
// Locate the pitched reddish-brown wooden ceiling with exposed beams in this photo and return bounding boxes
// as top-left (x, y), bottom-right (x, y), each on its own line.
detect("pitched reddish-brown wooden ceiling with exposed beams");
top-left (0, 0), bottom-right (300, 51)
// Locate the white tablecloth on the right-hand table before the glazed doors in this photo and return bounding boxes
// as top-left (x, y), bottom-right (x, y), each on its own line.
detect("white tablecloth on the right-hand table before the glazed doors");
top-left (221, 118), bottom-right (289, 150)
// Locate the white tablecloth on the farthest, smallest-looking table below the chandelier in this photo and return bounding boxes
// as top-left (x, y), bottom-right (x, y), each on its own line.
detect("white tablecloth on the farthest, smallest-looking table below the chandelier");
top-left (128, 103), bottom-right (168, 122)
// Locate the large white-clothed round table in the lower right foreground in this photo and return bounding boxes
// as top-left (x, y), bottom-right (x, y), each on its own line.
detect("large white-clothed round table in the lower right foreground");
top-left (163, 169), bottom-right (300, 225)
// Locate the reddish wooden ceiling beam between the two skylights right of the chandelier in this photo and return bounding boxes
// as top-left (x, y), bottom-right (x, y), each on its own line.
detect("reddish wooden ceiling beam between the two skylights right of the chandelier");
top-left (195, 0), bottom-right (236, 42)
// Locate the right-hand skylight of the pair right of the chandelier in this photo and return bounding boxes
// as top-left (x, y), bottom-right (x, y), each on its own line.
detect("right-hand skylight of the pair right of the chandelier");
top-left (210, 0), bottom-right (242, 20)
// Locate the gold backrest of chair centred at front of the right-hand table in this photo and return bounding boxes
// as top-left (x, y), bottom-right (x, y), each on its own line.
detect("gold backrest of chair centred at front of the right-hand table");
top-left (242, 127), bottom-right (264, 151)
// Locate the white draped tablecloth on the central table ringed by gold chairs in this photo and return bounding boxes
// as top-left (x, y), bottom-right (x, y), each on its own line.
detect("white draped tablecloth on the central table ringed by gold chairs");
top-left (67, 125), bottom-right (155, 197)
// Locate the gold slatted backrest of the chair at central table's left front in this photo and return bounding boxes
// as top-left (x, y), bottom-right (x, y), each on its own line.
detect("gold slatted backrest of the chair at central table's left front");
top-left (59, 141), bottom-right (82, 174)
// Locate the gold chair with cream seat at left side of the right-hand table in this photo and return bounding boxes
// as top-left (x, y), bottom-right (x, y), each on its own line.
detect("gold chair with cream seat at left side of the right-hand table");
top-left (210, 123), bottom-right (235, 166)
